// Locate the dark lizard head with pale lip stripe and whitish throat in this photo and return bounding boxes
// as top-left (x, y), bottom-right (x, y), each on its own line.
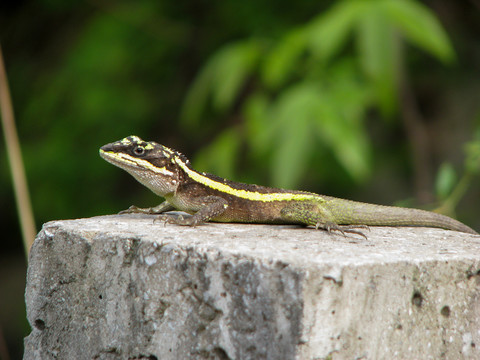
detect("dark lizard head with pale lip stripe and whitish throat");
top-left (100, 136), bottom-right (188, 196)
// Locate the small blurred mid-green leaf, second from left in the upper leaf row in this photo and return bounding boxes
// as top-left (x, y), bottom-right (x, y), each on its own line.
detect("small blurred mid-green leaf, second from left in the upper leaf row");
top-left (261, 27), bottom-right (306, 88)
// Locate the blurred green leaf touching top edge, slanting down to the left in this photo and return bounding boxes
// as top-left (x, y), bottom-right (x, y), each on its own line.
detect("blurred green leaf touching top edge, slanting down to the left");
top-left (306, 0), bottom-right (366, 62)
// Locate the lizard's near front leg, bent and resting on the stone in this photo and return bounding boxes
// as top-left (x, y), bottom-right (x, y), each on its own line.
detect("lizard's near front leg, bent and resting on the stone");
top-left (158, 196), bottom-right (228, 226)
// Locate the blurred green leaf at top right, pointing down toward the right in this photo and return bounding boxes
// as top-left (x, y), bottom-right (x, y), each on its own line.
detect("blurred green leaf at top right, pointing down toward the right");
top-left (381, 0), bottom-right (455, 62)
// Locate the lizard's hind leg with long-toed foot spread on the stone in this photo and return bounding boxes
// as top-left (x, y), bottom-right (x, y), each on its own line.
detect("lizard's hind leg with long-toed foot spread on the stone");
top-left (280, 203), bottom-right (368, 239)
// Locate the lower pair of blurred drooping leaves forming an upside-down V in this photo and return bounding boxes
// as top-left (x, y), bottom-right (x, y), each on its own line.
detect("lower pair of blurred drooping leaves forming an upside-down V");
top-left (271, 70), bottom-right (370, 187)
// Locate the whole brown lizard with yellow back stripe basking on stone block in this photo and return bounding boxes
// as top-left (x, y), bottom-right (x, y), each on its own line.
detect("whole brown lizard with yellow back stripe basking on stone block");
top-left (99, 136), bottom-right (478, 238)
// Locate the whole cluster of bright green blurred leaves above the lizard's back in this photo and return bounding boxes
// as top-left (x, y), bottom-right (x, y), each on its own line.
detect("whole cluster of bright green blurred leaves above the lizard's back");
top-left (183, 0), bottom-right (454, 187)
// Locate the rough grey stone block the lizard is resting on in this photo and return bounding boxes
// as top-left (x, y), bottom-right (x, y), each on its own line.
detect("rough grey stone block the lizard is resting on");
top-left (24, 215), bottom-right (480, 360)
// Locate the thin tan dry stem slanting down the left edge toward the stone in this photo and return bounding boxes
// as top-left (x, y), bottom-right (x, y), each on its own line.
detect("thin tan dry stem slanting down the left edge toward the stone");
top-left (0, 47), bottom-right (36, 259)
